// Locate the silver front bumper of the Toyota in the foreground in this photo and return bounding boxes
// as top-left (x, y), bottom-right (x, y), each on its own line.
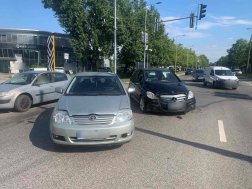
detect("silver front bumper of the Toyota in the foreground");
top-left (50, 118), bottom-right (134, 146)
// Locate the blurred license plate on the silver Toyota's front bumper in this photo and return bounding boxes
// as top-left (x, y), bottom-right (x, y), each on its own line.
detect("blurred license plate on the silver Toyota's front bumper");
top-left (76, 130), bottom-right (110, 139)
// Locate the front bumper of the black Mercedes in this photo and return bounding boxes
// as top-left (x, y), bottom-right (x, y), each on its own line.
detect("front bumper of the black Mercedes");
top-left (146, 98), bottom-right (196, 112)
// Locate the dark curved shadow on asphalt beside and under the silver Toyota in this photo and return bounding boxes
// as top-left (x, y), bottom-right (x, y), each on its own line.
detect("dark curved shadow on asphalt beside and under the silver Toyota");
top-left (28, 108), bottom-right (120, 153)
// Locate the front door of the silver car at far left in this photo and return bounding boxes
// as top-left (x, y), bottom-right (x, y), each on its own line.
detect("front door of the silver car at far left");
top-left (32, 73), bottom-right (55, 104)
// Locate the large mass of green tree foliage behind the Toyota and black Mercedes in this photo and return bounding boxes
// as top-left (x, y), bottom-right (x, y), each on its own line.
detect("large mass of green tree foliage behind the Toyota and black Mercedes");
top-left (42, 0), bottom-right (208, 68)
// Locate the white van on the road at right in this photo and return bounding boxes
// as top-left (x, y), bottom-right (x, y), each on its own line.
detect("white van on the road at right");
top-left (204, 66), bottom-right (239, 89)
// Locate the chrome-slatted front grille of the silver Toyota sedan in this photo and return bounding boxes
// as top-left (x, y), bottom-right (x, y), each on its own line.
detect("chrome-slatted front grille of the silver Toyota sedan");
top-left (73, 115), bottom-right (114, 125)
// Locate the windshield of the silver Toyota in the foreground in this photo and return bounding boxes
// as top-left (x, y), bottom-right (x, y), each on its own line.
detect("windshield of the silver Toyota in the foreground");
top-left (65, 76), bottom-right (125, 96)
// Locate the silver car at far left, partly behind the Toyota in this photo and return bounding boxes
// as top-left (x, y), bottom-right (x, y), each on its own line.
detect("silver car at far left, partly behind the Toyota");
top-left (0, 71), bottom-right (71, 112)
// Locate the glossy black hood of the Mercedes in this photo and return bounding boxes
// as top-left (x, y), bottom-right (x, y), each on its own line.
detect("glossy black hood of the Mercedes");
top-left (145, 82), bottom-right (188, 96)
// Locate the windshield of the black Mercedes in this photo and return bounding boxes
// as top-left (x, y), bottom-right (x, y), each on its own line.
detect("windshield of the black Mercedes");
top-left (144, 70), bottom-right (179, 82)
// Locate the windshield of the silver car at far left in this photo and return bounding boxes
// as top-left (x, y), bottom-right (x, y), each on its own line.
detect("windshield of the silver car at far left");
top-left (5, 73), bottom-right (38, 85)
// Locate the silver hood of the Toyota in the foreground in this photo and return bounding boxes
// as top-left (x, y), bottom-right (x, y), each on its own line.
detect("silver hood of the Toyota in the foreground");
top-left (58, 95), bottom-right (130, 116)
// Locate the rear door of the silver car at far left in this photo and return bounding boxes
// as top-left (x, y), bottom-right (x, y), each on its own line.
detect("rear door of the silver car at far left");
top-left (52, 73), bottom-right (68, 99)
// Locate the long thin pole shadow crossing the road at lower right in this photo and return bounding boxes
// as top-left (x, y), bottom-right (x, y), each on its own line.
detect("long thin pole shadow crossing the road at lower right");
top-left (135, 127), bottom-right (252, 163)
